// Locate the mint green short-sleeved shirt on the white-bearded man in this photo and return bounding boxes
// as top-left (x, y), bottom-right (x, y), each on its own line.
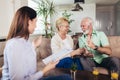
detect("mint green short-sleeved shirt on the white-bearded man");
top-left (79, 30), bottom-right (109, 64)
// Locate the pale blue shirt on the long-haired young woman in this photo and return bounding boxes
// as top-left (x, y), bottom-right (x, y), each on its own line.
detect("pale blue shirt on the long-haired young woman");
top-left (2, 37), bottom-right (43, 80)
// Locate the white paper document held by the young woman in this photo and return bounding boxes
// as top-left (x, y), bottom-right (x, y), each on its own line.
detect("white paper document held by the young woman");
top-left (42, 49), bottom-right (73, 64)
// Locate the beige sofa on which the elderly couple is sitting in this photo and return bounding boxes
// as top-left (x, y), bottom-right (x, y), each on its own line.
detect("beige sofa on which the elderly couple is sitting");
top-left (0, 35), bottom-right (120, 77)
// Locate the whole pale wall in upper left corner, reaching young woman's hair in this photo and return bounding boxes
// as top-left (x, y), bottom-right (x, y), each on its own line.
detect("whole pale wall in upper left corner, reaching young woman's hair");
top-left (0, 0), bottom-right (27, 38)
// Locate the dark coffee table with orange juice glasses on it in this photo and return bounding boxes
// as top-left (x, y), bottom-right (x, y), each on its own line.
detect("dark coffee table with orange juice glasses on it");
top-left (46, 68), bottom-right (111, 80)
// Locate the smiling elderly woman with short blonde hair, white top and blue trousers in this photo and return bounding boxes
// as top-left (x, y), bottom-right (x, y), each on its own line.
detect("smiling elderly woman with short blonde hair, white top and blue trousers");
top-left (51, 17), bottom-right (84, 70)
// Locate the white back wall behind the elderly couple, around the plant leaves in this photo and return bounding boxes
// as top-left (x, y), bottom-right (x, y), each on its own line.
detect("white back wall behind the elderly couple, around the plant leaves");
top-left (51, 3), bottom-right (96, 34)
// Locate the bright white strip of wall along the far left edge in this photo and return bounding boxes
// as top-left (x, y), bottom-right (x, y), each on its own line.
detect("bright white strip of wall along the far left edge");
top-left (0, 0), bottom-right (13, 37)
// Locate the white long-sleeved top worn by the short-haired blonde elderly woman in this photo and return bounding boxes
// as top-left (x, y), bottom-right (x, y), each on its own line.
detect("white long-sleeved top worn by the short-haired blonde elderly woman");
top-left (51, 33), bottom-right (73, 53)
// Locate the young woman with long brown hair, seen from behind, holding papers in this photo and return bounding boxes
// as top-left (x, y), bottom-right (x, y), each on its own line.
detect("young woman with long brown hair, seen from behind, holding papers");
top-left (2, 6), bottom-right (70, 80)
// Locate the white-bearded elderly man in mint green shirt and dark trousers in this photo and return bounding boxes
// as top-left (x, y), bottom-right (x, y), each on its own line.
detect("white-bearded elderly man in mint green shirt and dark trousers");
top-left (79, 17), bottom-right (120, 73)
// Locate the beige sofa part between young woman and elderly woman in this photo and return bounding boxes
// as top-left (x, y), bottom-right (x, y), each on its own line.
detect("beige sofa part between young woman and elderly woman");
top-left (36, 38), bottom-right (52, 71)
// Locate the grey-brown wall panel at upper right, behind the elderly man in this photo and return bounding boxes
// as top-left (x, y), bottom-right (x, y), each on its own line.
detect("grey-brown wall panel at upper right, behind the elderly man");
top-left (96, 5), bottom-right (116, 36)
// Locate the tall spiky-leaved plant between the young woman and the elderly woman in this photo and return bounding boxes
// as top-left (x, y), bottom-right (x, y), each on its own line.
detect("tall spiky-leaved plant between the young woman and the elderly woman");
top-left (33, 0), bottom-right (55, 38)
